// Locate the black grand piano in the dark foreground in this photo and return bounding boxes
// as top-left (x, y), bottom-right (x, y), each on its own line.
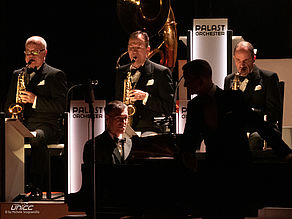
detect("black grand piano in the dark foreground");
top-left (66, 134), bottom-right (292, 218)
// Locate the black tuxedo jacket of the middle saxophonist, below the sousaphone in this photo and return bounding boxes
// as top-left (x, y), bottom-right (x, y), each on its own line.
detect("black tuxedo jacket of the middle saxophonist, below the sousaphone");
top-left (115, 60), bottom-right (174, 131)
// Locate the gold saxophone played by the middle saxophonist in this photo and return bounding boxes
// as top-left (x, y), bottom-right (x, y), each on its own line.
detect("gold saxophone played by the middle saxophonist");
top-left (123, 58), bottom-right (136, 117)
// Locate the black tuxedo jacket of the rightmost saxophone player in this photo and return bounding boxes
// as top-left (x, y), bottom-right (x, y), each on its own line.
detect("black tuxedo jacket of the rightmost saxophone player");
top-left (224, 65), bottom-right (282, 123)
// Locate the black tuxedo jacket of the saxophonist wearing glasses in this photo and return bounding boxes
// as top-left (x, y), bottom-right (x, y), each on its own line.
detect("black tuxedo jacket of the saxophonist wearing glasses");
top-left (5, 63), bottom-right (67, 128)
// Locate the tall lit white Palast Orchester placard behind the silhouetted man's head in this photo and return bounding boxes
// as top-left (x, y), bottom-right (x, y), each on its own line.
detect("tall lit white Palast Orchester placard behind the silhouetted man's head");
top-left (191, 18), bottom-right (228, 88)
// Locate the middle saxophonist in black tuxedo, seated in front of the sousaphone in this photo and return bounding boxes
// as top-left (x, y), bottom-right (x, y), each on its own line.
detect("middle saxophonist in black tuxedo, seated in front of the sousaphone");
top-left (115, 31), bottom-right (174, 133)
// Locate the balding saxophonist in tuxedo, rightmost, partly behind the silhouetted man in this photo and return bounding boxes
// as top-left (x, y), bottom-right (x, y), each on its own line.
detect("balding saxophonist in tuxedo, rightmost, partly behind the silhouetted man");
top-left (224, 41), bottom-right (282, 151)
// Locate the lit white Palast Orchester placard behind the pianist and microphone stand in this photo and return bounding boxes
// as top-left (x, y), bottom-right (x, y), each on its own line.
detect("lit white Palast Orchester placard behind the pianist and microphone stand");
top-left (68, 100), bottom-right (106, 194)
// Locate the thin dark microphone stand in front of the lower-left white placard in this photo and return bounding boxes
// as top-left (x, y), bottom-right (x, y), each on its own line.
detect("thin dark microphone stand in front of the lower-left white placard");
top-left (85, 80), bottom-right (96, 219)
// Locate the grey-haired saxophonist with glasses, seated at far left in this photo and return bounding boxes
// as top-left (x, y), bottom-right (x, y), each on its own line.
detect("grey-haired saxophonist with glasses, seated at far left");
top-left (4, 36), bottom-right (67, 200)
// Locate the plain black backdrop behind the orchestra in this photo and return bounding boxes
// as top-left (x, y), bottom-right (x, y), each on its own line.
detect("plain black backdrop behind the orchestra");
top-left (0, 0), bottom-right (292, 111)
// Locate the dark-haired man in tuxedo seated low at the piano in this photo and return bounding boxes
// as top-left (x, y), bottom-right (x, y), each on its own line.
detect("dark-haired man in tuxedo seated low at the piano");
top-left (69, 100), bottom-right (131, 216)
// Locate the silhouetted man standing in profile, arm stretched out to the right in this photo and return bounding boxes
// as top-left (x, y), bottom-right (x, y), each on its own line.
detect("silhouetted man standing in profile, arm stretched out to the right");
top-left (182, 59), bottom-right (292, 218)
